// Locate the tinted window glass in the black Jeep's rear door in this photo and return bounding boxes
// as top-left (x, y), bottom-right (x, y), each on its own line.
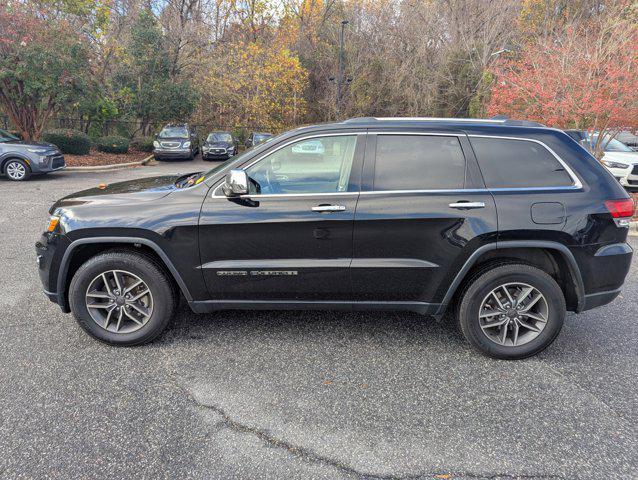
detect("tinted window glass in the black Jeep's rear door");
top-left (374, 135), bottom-right (465, 190)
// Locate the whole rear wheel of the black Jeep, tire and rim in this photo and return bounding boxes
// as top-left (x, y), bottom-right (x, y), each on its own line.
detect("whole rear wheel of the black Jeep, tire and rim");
top-left (458, 264), bottom-right (566, 360)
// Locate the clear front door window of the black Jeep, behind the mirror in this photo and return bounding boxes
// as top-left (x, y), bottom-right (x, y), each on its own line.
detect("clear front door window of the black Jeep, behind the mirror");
top-left (246, 135), bottom-right (357, 194)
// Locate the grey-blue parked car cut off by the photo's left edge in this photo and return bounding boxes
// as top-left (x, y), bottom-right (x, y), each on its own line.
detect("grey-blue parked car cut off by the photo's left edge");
top-left (0, 130), bottom-right (66, 182)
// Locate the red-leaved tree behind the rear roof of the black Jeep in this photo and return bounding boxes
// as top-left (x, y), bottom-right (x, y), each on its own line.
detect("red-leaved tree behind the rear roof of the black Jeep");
top-left (487, 15), bottom-right (638, 156)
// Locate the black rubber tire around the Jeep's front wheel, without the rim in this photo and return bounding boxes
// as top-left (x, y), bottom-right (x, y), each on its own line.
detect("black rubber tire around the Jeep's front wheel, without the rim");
top-left (69, 250), bottom-right (179, 346)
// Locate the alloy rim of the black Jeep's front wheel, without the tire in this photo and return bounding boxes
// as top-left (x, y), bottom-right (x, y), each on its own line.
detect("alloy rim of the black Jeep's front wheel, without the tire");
top-left (85, 270), bottom-right (153, 333)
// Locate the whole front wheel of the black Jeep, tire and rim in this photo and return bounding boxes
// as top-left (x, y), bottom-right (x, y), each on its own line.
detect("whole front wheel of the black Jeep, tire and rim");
top-left (69, 251), bottom-right (179, 345)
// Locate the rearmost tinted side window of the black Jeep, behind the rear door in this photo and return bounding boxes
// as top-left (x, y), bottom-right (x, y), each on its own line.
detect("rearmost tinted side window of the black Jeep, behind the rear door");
top-left (470, 137), bottom-right (574, 188)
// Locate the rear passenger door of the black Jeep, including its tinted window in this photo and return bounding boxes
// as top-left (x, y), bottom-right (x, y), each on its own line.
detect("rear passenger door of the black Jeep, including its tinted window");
top-left (352, 131), bottom-right (497, 313)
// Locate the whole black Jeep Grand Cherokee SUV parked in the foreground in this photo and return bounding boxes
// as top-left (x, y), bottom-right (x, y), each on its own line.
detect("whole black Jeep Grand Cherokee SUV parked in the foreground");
top-left (36, 119), bottom-right (633, 359)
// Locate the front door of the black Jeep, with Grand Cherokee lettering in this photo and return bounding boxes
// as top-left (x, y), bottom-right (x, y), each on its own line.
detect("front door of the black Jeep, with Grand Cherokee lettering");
top-left (199, 132), bottom-right (365, 302)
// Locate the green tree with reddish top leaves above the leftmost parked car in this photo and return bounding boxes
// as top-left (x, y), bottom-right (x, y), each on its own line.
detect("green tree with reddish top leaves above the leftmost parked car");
top-left (0, 3), bottom-right (90, 140)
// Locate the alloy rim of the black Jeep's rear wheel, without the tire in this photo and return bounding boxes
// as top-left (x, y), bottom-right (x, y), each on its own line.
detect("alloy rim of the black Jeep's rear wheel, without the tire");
top-left (478, 282), bottom-right (549, 347)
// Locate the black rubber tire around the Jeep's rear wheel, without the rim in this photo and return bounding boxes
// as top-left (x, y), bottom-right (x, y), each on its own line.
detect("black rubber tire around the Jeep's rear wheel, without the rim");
top-left (457, 263), bottom-right (566, 360)
